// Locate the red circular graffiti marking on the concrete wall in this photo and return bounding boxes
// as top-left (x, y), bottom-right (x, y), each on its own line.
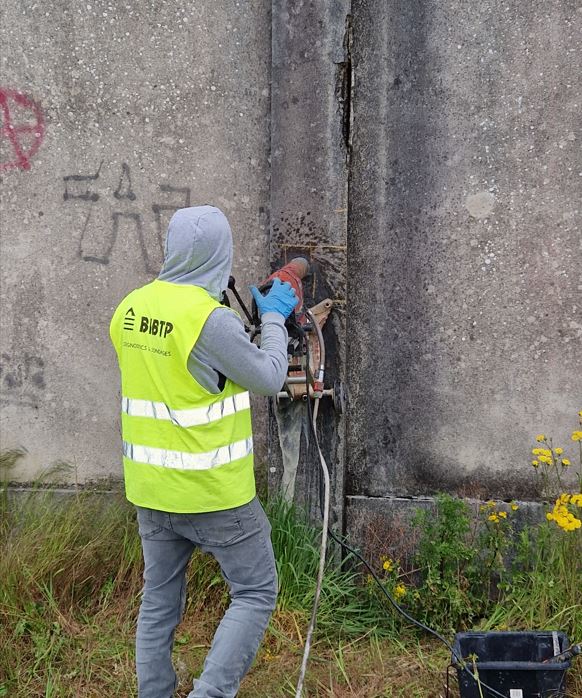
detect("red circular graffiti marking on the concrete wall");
top-left (0, 87), bottom-right (44, 171)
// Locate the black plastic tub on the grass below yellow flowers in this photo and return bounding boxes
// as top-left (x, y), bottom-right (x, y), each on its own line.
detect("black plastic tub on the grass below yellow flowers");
top-left (452, 631), bottom-right (570, 698)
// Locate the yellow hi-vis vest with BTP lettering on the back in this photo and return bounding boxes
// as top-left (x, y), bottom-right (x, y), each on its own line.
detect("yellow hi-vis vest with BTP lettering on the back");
top-left (110, 280), bottom-right (255, 513)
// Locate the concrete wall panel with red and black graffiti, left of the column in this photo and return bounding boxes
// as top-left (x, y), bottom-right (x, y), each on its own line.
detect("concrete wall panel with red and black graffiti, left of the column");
top-left (0, 0), bottom-right (271, 481)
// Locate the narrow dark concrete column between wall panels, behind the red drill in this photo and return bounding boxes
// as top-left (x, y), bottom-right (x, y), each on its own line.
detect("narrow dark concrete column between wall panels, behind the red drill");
top-left (269, 0), bottom-right (351, 522)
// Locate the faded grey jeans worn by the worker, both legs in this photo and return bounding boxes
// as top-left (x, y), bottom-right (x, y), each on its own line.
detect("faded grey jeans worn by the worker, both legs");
top-left (136, 497), bottom-right (277, 698)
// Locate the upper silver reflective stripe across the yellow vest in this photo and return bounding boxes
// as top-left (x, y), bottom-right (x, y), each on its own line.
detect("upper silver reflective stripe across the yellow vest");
top-left (121, 392), bottom-right (251, 426)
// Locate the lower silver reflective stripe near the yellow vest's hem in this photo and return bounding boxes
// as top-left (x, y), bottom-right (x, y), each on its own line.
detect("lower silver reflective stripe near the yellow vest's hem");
top-left (123, 437), bottom-right (253, 470)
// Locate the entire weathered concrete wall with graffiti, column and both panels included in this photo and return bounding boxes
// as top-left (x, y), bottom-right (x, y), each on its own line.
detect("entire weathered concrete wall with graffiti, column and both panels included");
top-left (0, 0), bottom-right (582, 528)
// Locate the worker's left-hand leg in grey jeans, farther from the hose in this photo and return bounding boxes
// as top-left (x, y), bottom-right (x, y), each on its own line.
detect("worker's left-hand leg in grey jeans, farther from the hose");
top-left (136, 507), bottom-right (194, 698)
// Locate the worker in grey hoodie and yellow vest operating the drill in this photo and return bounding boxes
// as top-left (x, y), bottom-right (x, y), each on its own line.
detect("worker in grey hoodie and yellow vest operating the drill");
top-left (110, 206), bottom-right (297, 698)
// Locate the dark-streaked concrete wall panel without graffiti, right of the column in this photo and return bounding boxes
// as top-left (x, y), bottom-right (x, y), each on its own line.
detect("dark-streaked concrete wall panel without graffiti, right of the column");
top-left (346, 0), bottom-right (582, 507)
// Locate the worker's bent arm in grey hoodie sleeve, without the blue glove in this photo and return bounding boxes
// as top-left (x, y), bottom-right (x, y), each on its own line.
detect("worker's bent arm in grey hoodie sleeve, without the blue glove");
top-left (188, 308), bottom-right (287, 395)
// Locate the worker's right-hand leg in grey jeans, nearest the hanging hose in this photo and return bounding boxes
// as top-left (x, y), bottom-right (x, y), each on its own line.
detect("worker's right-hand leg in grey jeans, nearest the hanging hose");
top-left (188, 498), bottom-right (277, 698)
